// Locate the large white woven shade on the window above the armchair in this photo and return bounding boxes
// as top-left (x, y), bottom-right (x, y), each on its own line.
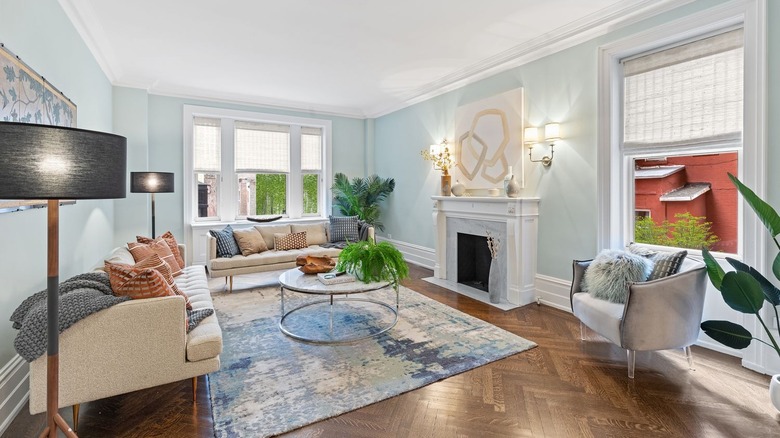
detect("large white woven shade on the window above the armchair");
top-left (623, 29), bottom-right (744, 147)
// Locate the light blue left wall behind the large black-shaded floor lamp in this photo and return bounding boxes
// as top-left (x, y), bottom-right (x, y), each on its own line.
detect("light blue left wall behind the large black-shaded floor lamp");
top-left (0, 0), bottom-right (114, 366)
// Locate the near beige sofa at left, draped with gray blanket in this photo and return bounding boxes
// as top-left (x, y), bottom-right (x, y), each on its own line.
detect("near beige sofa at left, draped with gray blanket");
top-left (30, 245), bottom-right (222, 424)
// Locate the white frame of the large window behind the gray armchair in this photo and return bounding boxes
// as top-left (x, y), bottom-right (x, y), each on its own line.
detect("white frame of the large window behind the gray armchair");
top-left (597, 0), bottom-right (770, 371)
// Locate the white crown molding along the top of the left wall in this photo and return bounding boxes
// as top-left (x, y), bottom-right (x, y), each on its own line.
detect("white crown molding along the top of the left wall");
top-left (59, 0), bottom-right (122, 80)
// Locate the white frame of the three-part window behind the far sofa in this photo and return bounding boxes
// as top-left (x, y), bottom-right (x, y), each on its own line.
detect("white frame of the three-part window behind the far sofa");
top-left (183, 105), bottom-right (332, 226)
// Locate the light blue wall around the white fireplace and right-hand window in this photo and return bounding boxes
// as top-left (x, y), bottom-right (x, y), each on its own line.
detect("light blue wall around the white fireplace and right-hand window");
top-left (375, 0), bottom-right (760, 279)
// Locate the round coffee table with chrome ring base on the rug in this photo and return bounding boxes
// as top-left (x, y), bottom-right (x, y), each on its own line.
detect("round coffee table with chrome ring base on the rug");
top-left (279, 268), bottom-right (399, 344)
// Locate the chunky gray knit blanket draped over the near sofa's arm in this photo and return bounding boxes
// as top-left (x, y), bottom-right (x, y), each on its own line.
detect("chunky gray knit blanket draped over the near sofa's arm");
top-left (11, 272), bottom-right (130, 362)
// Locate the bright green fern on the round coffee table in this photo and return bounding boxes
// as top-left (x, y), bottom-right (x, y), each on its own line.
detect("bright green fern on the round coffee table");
top-left (336, 241), bottom-right (409, 287)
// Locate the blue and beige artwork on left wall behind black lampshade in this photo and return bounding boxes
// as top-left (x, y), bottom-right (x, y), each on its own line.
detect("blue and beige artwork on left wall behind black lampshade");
top-left (0, 44), bottom-right (76, 213)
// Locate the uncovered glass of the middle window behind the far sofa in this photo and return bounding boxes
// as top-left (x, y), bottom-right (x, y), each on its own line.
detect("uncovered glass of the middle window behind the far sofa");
top-left (237, 173), bottom-right (287, 217)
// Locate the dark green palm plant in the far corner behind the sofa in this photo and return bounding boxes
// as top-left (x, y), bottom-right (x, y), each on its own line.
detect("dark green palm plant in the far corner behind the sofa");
top-left (331, 173), bottom-right (395, 231)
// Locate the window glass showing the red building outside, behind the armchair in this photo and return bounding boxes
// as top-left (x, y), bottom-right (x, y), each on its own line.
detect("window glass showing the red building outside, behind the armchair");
top-left (634, 152), bottom-right (738, 254)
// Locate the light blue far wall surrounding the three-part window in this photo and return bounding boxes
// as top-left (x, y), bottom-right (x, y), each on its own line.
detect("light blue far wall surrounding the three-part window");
top-left (114, 93), bottom-right (367, 243)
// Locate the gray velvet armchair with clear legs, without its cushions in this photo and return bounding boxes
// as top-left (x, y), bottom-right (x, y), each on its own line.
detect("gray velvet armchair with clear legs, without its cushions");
top-left (570, 258), bottom-right (707, 379)
